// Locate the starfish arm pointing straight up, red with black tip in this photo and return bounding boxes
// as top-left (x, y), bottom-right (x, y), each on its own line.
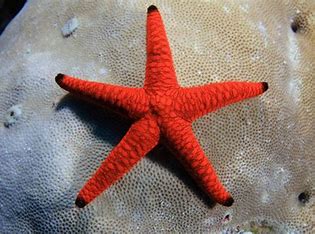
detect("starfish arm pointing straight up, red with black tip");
top-left (144, 6), bottom-right (178, 92)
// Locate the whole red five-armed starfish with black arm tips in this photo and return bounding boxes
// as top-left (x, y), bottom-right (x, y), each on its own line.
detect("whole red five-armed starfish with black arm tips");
top-left (56, 6), bottom-right (268, 207)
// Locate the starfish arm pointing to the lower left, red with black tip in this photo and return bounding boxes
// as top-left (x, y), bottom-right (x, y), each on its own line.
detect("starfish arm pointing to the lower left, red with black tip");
top-left (75, 115), bottom-right (160, 208)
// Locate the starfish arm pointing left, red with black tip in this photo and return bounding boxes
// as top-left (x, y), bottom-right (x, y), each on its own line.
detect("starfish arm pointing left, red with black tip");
top-left (56, 74), bottom-right (148, 119)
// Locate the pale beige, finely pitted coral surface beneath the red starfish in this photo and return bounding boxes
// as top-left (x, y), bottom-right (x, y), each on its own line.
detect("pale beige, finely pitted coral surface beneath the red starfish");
top-left (0, 0), bottom-right (315, 233)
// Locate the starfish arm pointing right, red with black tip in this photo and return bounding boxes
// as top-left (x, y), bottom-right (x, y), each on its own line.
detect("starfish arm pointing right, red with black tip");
top-left (176, 82), bottom-right (268, 121)
